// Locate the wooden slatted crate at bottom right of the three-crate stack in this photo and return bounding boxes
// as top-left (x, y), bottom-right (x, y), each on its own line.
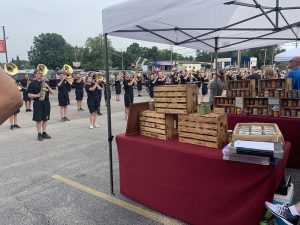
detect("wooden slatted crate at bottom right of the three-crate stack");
top-left (178, 113), bottom-right (227, 148)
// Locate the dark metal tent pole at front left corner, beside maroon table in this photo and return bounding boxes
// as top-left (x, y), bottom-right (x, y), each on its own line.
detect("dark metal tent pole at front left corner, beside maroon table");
top-left (104, 34), bottom-right (115, 195)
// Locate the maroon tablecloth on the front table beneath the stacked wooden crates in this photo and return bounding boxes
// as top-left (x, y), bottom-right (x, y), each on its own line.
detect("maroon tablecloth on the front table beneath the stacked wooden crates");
top-left (116, 135), bottom-right (290, 225)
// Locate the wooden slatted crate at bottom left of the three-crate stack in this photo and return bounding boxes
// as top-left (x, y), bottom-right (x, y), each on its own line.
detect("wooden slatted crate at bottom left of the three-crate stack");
top-left (139, 110), bottom-right (178, 140)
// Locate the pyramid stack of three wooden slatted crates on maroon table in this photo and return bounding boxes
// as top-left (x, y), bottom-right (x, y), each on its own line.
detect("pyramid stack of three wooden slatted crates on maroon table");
top-left (139, 84), bottom-right (227, 148)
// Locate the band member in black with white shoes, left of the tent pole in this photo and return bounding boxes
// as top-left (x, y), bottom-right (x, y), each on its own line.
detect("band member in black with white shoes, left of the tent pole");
top-left (85, 73), bottom-right (101, 129)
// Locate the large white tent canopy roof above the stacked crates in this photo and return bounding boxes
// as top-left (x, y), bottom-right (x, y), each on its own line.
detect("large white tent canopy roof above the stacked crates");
top-left (102, 0), bottom-right (300, 52)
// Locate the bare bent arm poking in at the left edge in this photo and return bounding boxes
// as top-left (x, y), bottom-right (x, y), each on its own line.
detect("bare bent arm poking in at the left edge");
top-left (0, 68), bottom-right (23, 124)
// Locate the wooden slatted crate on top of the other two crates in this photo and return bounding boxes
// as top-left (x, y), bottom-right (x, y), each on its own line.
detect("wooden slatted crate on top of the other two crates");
top-left (154, 84), bottom-right (198, 114)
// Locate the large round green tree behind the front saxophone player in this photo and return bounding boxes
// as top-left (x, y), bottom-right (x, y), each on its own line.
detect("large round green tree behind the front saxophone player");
top-left (28, 33), bottom-right (74, 69)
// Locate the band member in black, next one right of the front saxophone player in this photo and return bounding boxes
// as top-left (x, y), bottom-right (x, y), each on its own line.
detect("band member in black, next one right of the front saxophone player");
top-left (57, 72), bottom-right (71, 122)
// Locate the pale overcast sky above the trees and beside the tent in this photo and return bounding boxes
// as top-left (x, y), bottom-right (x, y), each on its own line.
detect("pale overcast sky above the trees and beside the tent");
top-left (0, 0), bottom-right (293, 62)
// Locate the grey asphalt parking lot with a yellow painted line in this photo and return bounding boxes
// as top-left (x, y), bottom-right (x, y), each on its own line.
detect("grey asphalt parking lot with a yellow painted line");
top-left (0, 89), bottom-right (300, 225)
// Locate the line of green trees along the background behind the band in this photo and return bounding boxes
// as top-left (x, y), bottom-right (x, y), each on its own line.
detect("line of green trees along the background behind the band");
top-left (7, 33), bottom-right (284, 70)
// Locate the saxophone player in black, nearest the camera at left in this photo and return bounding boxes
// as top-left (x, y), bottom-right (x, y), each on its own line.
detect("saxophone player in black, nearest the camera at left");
top-left (28, 70), bottom-right (53, 141)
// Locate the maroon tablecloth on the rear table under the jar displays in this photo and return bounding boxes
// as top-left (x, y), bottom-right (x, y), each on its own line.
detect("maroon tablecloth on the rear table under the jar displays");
top-left (228, 114), bottom-right (300, 169)
